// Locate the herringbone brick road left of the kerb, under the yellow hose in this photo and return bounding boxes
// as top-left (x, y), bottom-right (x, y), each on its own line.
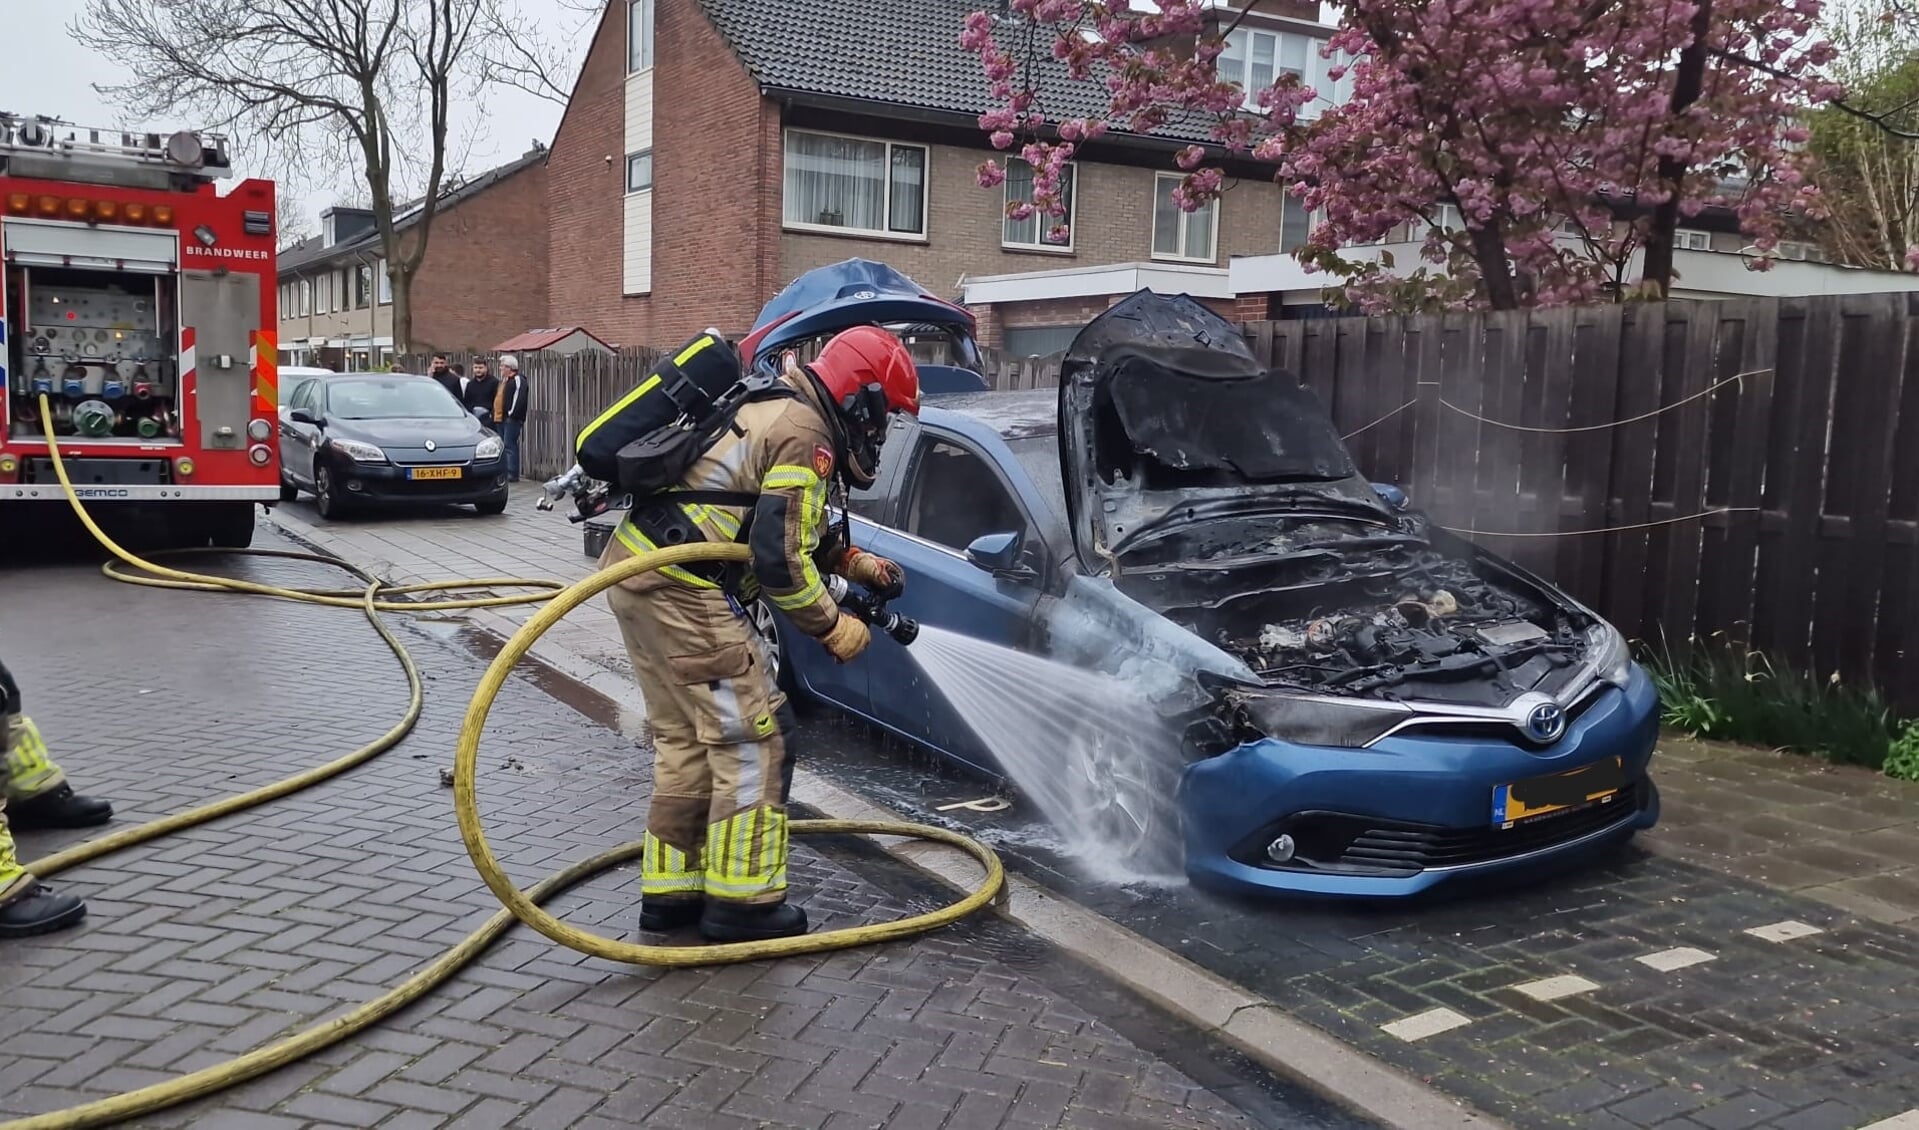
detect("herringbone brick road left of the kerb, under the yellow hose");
top-left (0, 525), bottom-right (1359, 1130)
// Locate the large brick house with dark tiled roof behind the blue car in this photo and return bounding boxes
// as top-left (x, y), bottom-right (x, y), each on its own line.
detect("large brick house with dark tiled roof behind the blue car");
top-left (547, 0), bottom-right (1330, 353)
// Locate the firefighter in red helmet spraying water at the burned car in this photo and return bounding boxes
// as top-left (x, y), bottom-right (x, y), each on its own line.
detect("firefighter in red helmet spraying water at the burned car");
top-left (601, 326), bottom-right (919, 942)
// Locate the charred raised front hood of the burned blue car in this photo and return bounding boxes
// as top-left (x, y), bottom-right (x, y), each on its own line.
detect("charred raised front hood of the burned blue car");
top-left (1059, 290), bottom-right (1389, 574)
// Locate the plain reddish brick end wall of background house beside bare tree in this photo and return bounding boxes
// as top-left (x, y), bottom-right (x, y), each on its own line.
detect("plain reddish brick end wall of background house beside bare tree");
top-left (413, 161), bottom-right (551, 351)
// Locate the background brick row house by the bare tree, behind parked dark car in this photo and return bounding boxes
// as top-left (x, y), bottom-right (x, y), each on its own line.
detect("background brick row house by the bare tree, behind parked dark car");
top-left (278, 148), bottom-right (547, 368)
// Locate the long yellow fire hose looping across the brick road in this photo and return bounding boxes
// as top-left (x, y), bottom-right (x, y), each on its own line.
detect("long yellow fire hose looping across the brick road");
top-left (0, 395), bottom-right (1006, 1130)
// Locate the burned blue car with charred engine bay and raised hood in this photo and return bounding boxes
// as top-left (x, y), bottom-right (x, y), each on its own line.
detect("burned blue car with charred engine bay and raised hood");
top-left (740, 264), bottom-right (1660, 898)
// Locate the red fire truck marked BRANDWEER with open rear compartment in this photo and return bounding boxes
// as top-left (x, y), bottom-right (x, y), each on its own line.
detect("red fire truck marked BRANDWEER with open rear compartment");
top-left (0, 113), bottom-right (280, 549)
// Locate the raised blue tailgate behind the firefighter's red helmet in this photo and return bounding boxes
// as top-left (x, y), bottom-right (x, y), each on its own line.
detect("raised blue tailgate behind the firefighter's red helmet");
top-left (739, 259), bottom-right (986, 393)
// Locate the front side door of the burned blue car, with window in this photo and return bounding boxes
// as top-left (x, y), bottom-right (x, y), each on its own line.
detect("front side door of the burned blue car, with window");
top-left (862, 428), bottom-right (1044, 769)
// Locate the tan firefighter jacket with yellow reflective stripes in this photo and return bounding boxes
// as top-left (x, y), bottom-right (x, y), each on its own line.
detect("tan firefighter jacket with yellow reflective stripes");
top-left (601, 363), bottom-right (841, 637)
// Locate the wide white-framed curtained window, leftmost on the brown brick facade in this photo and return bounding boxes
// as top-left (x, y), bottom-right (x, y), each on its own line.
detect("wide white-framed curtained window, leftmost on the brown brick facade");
top-left (785, 130), bottom-right (927, 236)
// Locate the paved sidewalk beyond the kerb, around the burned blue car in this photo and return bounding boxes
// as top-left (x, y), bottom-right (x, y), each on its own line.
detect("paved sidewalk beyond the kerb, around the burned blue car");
top-left (262, 491), bottom-right (1919, 1130)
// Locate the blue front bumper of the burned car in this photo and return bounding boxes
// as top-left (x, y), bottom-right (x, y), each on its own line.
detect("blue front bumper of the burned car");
top-left (1180, 666), bottom-right (1660, 898)
